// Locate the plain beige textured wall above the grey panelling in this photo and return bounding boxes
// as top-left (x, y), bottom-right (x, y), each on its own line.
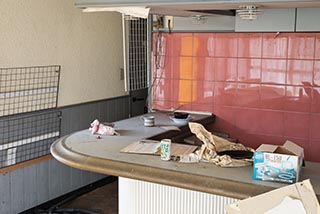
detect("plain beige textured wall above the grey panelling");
top-left (0, 0), bottom-right (125, 106)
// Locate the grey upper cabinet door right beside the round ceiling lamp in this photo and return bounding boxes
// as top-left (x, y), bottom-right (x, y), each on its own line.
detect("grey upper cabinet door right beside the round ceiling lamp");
top-left (235, 8), bottom-right (295, 32)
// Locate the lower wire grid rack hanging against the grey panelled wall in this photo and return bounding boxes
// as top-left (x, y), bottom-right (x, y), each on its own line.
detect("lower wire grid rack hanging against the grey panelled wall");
top-left (0, 110), bottom-right (61, 168)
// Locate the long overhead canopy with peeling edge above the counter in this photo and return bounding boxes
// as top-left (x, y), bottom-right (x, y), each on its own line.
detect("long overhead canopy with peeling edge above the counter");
top-left (75, 0), bottom-right (320, 17)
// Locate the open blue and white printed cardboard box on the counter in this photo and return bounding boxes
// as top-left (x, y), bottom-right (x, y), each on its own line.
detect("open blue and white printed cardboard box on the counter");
top-left (253, 141), bottom-right (304, 183)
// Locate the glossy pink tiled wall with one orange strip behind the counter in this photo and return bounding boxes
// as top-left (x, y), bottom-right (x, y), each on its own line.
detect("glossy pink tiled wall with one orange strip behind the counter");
top-left (153, 33), bottom-right (320, 162)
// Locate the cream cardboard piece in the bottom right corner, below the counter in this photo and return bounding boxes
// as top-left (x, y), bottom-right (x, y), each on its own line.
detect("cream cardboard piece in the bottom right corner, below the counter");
top-left (225, 180), bottom-right (320, 214)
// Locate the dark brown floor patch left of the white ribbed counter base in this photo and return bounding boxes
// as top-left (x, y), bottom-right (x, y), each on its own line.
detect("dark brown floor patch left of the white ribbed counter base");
top-left (62, 181), bottom-right (118, 214)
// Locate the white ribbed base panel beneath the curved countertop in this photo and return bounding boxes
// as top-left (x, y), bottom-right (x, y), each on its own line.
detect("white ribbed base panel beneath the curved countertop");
top-left (119, 177), bottom-right (238, 214)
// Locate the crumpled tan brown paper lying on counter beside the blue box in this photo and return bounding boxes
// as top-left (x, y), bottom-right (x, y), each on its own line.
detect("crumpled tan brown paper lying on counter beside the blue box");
top-left (189, 122), bottom-right (254, 167)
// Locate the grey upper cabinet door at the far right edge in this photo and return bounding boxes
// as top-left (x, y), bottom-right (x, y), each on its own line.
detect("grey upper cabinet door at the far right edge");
top-left (297, 7), bottom-right (320, 32)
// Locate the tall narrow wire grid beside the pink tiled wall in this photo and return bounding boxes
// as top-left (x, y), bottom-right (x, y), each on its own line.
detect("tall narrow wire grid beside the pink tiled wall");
top-left (126, 18), bottom-right (148, 91)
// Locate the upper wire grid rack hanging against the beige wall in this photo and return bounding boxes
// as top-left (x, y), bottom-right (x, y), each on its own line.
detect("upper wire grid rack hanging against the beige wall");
top-left (0, 65), bottom-right (60, 117)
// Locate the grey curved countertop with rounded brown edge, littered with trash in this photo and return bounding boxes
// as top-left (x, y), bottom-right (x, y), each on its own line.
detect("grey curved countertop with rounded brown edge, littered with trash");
top-left (51, 112), bottom-right (320, 199)
